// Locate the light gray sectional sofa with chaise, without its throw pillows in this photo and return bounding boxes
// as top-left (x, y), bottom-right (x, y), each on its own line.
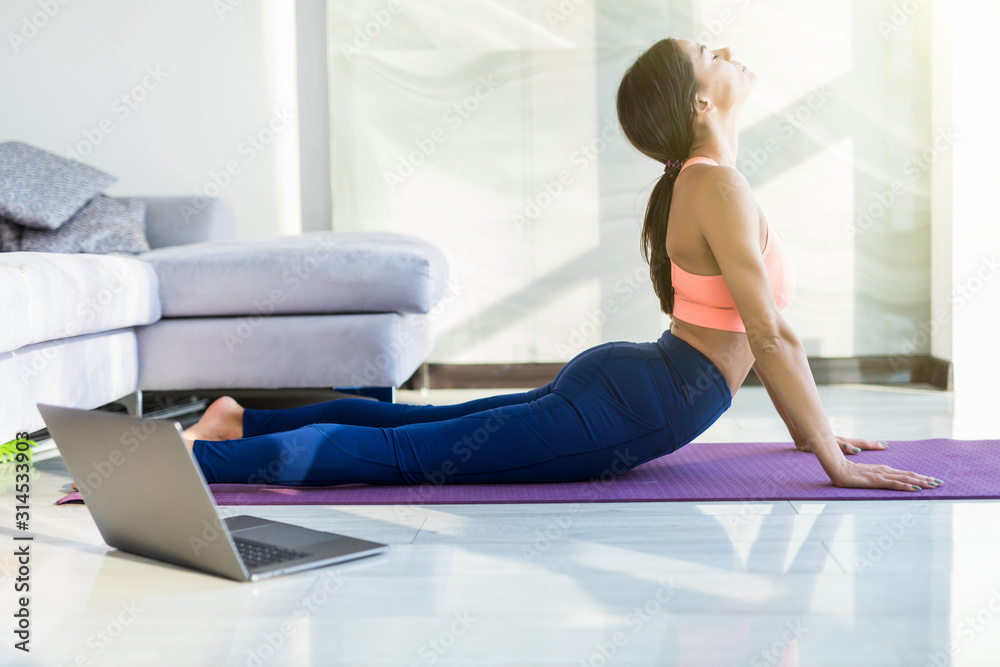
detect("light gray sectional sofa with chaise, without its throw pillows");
top-left (0, 197), bottom-right (448, 440)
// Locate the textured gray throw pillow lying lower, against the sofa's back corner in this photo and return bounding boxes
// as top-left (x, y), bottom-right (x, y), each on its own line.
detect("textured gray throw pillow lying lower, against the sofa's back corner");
top-left (21, 195), bottom-right (149, 254)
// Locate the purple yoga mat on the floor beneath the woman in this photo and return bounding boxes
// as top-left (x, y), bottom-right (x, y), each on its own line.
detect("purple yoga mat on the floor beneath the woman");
top-left (57, 438), bottom-right (1000, 505)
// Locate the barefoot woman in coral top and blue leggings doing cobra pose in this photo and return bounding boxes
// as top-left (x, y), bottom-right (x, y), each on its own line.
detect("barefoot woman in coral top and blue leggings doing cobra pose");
top-left (178, 39), bottom-right (940, 491)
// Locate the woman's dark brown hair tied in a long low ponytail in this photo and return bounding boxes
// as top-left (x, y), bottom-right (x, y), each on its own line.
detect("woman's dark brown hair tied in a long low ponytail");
top-left (615, 38), bottom-right (698, 315)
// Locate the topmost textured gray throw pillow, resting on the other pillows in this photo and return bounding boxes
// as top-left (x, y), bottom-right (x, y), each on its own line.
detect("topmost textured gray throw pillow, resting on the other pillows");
top-left (0, 141), bottom-right (118, 229)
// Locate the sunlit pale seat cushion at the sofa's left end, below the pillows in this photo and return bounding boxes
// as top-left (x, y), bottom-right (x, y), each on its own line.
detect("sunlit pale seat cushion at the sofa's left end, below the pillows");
top-left (0, 252), bottom-right (160, 352)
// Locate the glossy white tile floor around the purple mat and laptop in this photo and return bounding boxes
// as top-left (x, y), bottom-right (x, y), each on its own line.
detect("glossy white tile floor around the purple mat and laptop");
top-left (0, 385), bottom-right (1000, 667)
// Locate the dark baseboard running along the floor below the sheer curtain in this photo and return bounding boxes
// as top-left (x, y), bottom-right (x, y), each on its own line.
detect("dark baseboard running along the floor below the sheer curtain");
top-left (400, 354), bottom-right (954, 391)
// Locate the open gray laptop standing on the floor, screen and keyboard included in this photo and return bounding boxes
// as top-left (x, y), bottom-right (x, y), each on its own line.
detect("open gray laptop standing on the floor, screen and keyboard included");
top-left (37, 403), bottom-right (389, 581)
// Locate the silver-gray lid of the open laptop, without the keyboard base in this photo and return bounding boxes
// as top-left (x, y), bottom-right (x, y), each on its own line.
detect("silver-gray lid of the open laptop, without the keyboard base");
top-left (38, 403), bottom-right (249, 581)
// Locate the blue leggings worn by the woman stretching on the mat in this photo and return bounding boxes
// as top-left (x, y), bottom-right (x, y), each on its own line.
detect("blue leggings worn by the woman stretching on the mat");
top-left (194, 330), bottom-right (732, 486)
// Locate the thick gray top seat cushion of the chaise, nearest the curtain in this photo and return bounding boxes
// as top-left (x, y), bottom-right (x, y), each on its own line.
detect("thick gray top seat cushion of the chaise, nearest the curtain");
top-left (138, 232), bottom-right (448, 317)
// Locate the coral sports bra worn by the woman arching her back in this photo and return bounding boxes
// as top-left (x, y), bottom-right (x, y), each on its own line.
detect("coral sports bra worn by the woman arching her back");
top-left (670, 156), bottom-right (795, 333)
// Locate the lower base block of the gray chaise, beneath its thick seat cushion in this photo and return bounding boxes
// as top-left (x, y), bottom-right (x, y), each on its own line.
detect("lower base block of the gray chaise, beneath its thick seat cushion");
top-left (135, 313), bottom-right (434, 391)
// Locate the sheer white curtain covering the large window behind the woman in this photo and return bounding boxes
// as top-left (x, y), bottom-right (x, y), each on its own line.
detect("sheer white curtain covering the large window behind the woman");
top-left (327, 0), bottom-right (932, 363)
